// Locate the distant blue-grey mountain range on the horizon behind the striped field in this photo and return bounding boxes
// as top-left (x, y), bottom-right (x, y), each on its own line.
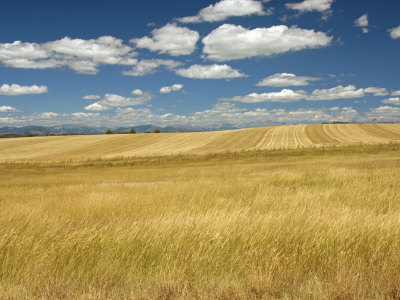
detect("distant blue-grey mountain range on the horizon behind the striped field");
top-left (0, 125), bottom-right (222, 137)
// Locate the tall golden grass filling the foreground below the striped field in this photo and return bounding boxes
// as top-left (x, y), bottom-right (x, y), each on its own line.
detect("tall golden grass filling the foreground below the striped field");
top-left (0, 145), bottom-right (400, 299)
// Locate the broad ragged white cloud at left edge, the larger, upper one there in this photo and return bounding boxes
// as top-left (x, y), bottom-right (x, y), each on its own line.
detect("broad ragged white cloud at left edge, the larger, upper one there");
top-left (0, 36), bottom-right (137, 74)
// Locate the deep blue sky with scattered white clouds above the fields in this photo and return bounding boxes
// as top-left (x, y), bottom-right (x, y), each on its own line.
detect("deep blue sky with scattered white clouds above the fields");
top-left (0, 0), bottom-right (400, 129)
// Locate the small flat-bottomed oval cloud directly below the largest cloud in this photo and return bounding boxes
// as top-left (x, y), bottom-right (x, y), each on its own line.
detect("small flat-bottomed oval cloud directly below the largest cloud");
top-left (175, 64), bottom-right (246, 79)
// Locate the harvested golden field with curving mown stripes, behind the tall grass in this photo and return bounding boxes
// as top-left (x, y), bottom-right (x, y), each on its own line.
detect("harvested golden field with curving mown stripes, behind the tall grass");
top-left (0, 124), bottom-right (400, 161)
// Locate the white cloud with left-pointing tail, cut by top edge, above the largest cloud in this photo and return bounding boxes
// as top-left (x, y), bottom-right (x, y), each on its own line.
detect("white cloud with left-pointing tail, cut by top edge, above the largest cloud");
top-left (178, 0), bottom-right (265, 23)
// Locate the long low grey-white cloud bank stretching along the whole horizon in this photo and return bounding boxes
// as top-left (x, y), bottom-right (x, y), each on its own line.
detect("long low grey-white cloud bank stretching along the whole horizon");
top-left (0, 102), bottom-right (384, 129)
